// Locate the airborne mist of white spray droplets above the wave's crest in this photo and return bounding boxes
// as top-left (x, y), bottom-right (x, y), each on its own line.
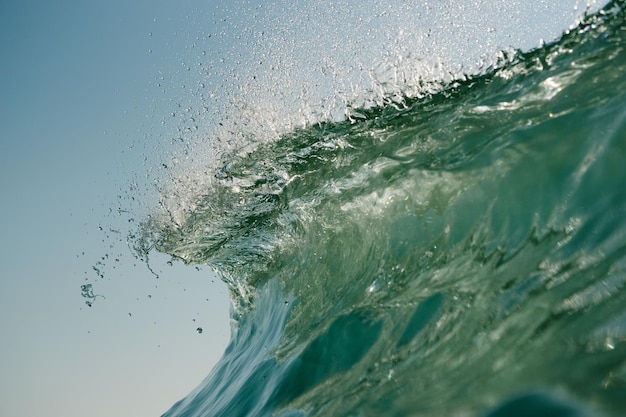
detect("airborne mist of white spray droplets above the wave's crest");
top-left (143, 0), bottom-right (601, 231)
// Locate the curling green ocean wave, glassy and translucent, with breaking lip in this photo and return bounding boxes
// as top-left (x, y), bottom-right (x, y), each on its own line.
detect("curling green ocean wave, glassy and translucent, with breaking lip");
top-left (135, 1), bottom-right (626, 417)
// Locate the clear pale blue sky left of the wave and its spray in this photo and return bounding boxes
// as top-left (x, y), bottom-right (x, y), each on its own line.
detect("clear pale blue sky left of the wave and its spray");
top-left (0, 0), bottom-right (604, 417)
